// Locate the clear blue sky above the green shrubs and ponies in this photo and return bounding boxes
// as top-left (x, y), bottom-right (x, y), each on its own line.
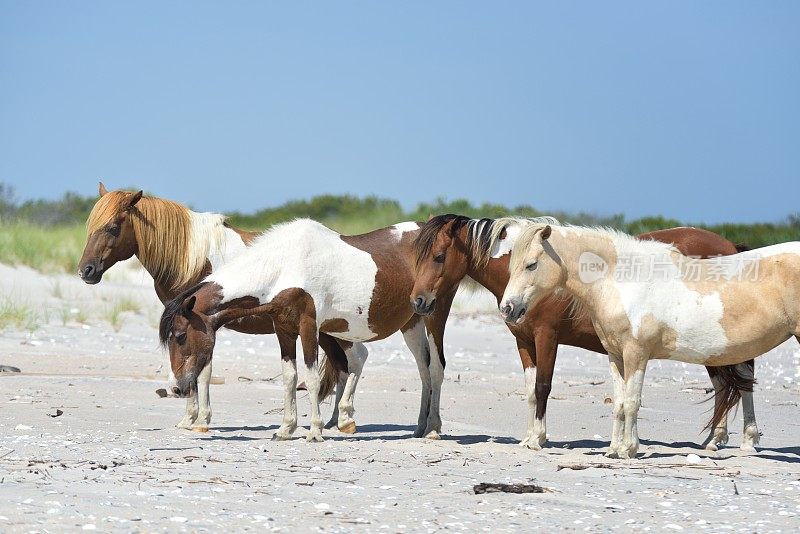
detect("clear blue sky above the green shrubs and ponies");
top-left (0, 0), bottom-right (800, 222)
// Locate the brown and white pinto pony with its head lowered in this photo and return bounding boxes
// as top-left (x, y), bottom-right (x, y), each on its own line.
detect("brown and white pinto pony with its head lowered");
top-left (159, 219), bottom-right (453, 441)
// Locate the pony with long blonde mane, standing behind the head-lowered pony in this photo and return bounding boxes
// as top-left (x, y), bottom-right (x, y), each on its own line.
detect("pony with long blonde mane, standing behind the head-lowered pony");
top-left (78, 186), bottom-right (366, 432)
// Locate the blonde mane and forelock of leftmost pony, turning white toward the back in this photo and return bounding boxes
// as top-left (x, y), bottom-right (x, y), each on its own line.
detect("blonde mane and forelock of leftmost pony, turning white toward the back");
top-left (86, 191), bottom-right (225, 289)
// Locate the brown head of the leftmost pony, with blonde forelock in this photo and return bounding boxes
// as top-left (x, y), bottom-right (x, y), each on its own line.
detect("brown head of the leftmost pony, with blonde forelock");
top-left (78, 182), bottom-right (142, 284)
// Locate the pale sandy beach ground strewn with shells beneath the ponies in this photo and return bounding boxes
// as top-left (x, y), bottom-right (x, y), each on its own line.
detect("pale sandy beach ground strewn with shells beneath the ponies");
top-left (0, 266), bottom-right (800, 532)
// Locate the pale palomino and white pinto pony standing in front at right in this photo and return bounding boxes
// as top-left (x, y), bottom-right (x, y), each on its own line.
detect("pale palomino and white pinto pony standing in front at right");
top-left (500, 224), bottom-right (800, 458)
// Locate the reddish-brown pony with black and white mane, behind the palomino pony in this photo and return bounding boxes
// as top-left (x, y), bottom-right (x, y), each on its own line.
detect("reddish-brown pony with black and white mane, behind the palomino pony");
top-left (411, 214), bottom-right (759, 450)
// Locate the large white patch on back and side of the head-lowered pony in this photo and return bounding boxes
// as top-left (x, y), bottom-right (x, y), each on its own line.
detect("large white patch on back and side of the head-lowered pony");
top-left (206, 219), bottom-right (378, 341)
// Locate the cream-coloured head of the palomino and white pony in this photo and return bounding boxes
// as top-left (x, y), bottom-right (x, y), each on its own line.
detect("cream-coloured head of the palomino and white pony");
top-left (500, 224), bottom-right (564, 324)
